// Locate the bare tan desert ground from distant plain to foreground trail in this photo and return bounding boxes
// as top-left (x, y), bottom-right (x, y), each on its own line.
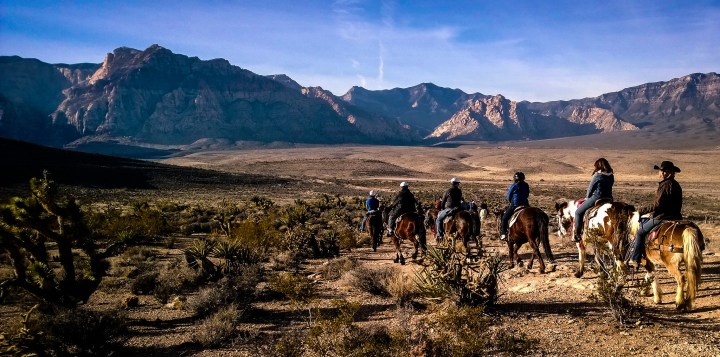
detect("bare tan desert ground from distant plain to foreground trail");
top-left (3, 143), bottom-right (720, 356)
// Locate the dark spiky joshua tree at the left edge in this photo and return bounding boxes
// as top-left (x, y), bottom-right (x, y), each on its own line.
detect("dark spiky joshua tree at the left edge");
top-left (0, 171), bottom-right (106, 306)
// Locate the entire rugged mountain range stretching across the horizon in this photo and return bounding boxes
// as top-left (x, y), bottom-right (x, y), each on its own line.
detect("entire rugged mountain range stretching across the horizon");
top-left (0, 45), bottom-right (720, 153)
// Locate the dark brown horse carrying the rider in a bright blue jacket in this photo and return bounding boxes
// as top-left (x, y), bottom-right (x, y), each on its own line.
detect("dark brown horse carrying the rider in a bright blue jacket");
top-left (495, 206), bottom-right (555, 273)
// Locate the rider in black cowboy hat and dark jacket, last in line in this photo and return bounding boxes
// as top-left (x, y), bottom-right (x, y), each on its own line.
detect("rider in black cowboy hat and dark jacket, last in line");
top-left (631, 161), bottom-right (682, 268)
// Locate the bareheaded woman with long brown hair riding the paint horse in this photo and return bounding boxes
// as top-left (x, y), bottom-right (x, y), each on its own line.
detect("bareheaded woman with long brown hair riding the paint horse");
top-left (573, 157), bottom-right (615, 242)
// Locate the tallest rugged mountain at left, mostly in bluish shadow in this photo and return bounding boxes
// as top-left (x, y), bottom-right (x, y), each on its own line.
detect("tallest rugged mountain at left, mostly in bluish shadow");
top-left (52, 46), bottom-right (363, 143)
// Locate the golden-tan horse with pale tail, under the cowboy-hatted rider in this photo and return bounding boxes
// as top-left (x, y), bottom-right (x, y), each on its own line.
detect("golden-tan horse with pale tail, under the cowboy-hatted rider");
top-left (630, 211), bottom-right (705, 311)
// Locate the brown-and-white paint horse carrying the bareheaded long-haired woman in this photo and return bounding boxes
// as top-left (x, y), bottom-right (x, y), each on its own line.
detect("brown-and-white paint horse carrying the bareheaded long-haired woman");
top-left (555, 200), bottom-right (635, 278)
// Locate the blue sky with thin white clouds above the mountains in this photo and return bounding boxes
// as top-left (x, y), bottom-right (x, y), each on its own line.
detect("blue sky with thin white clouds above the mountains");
top-left (0, 0), bottom-right (720, 101)
